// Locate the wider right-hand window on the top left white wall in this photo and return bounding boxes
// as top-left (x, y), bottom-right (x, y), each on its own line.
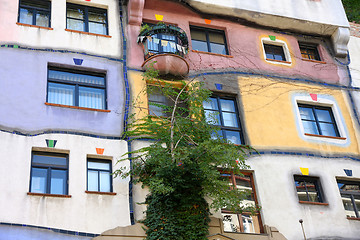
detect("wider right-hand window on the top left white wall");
top-left (66, 3), bottom-right (108, 35)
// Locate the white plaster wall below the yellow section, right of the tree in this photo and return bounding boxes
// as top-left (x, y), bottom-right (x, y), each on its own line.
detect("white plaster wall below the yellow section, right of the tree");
top-left (247, 155), bottom-right (360, 240)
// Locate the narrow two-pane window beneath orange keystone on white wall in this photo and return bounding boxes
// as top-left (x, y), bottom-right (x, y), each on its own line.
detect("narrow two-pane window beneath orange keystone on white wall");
top-left (87, 159), bottom-right (112, 192)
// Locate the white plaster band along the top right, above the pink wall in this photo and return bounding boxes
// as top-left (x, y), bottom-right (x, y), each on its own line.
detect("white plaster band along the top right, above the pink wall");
top-left (186, 0), bottom-right (349, 35)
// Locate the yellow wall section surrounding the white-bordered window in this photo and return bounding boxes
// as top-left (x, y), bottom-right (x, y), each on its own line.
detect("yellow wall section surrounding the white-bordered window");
top-left (238, 77), bottom-right (359, 154)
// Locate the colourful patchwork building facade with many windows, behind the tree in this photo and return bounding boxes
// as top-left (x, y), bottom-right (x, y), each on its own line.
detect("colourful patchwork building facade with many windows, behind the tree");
top-left (0, 0), bottom-right (360, 240)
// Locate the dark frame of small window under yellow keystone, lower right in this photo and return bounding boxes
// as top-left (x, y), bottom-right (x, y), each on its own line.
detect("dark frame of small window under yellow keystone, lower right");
top-left (293, 175), bottom-right (325, 204)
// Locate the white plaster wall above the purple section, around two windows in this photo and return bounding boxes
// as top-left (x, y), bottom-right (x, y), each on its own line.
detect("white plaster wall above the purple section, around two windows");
top-left (0, 0), bottom-right (122, 57)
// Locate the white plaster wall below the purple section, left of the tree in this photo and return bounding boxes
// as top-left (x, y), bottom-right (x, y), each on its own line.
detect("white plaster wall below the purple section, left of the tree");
top-left (0, 132), bottom-right (130, 234)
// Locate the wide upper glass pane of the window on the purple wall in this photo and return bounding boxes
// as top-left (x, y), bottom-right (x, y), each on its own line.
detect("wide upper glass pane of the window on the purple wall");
top-left (49, 70), bottom-right (105, 86)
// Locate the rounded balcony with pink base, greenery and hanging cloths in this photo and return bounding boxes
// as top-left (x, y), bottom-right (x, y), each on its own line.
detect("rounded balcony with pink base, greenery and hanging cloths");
top-left (138, 23), bottom-right (189, 77)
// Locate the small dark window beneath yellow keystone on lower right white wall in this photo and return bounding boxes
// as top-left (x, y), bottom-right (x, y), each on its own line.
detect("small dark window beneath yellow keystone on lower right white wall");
top-left (294, 175), bottom-right (324, 203)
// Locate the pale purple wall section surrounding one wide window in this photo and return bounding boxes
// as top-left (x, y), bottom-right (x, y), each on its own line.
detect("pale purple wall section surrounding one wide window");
top-left (0, 48), bottom-right (125, 137)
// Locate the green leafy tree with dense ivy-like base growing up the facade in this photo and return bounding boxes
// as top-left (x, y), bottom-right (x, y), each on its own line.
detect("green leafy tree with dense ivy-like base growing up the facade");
top-left (115, 69), bottom-right (255, 240)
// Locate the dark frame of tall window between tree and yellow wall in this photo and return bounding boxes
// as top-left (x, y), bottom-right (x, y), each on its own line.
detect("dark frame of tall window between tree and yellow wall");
top-left (204, 94), bottom-right (245, 144)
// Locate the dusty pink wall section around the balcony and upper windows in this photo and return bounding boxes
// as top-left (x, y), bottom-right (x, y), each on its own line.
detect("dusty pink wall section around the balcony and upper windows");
top-left (128, 0), bottom-right (339, 83)
